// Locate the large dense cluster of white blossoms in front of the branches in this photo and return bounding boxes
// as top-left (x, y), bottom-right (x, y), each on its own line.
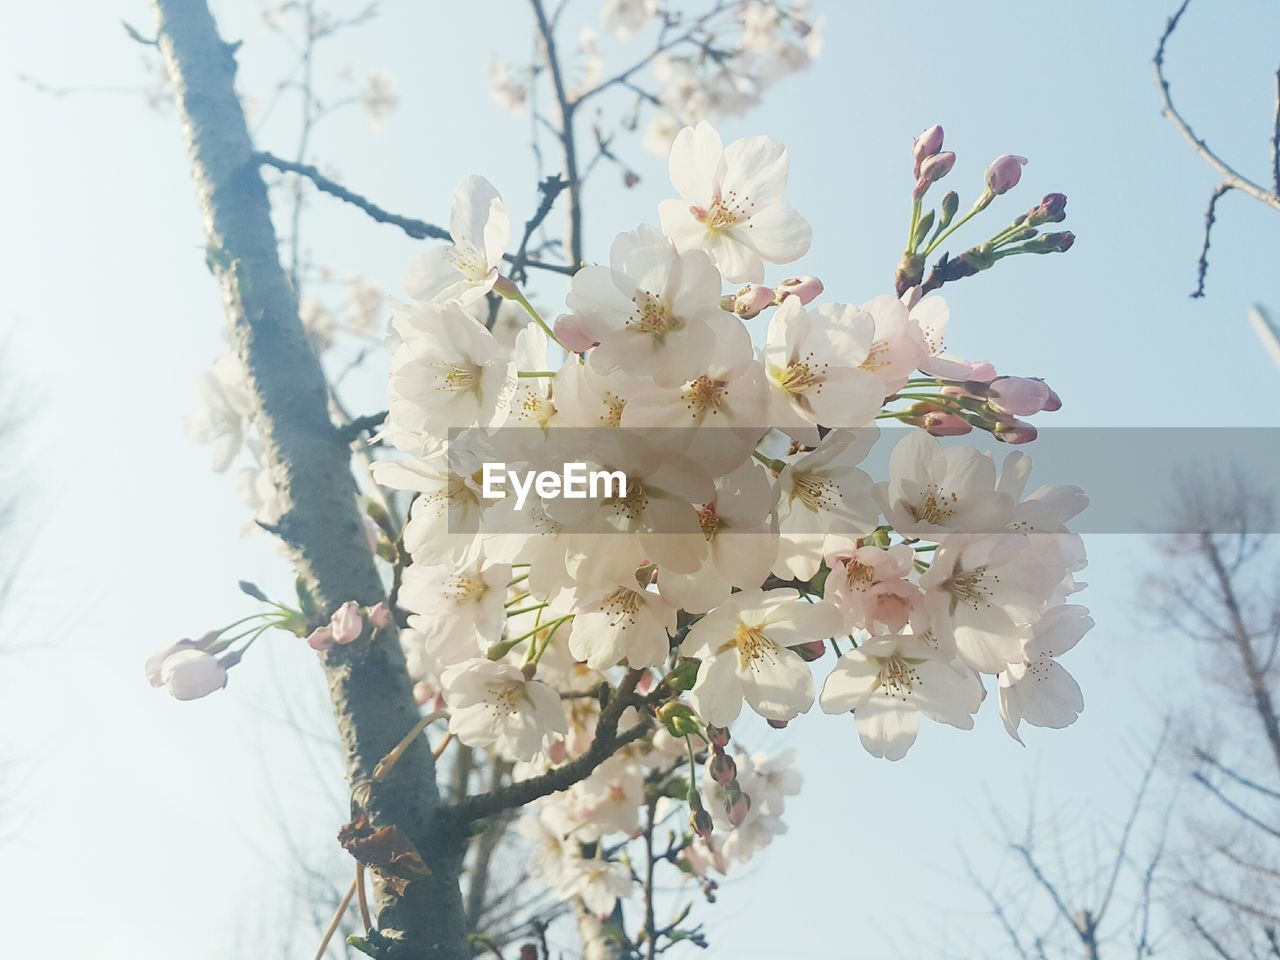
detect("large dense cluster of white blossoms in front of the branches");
top-left (374, 114), bottom-right (1092, 913)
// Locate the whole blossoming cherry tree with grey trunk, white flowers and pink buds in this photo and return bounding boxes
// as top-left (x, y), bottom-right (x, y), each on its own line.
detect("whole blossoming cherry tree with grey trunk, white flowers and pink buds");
top-left (143, 0), bottom-right (1092, 960)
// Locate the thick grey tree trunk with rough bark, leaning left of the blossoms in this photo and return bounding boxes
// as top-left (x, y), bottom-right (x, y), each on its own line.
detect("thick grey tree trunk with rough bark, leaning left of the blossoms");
top-left (154, 0), bottom-right (470, 960)
